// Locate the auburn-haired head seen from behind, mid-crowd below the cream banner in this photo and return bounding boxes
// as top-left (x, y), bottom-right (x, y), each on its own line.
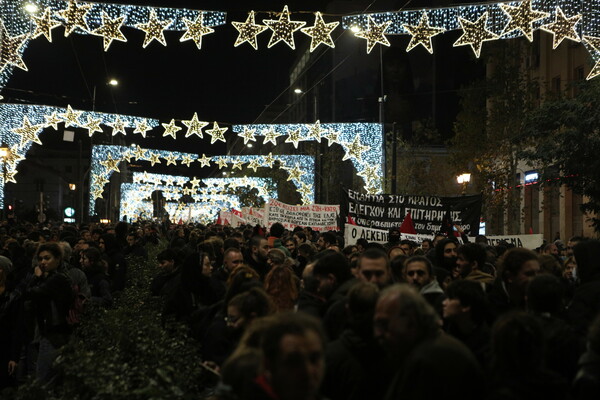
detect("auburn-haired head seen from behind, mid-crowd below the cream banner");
top-left (265, 266), bottom-right (298, 311)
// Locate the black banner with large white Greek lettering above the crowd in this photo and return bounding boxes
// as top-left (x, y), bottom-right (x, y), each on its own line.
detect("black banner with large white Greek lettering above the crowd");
top-left (344, 190), bottom-right (482, 235)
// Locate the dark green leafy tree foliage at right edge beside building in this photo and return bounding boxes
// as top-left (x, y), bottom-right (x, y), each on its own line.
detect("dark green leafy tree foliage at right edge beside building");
top-left (520, 79), bottom-right (600, 232)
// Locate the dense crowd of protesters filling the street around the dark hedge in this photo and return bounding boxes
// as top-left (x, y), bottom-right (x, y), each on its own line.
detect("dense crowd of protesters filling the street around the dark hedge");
top-left (0, 222), bottom-right (600, 400)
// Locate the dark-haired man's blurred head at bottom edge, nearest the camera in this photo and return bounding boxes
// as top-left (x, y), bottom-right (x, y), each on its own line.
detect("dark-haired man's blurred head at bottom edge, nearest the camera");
top-left (259, 313), bottom-right (325, 400)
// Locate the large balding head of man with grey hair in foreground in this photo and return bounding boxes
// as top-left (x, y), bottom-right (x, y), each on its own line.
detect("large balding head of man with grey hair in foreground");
top-left (373, 283), bottom-right (440, 362)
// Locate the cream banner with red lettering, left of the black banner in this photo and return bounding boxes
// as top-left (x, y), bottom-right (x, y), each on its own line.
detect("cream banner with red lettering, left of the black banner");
top-left (265, 199), bottom-right (340, 231)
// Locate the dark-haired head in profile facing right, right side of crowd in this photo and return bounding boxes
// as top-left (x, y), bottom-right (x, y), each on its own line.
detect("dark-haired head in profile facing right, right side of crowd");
top-left (499, 247), bottom-right (540, 307)
